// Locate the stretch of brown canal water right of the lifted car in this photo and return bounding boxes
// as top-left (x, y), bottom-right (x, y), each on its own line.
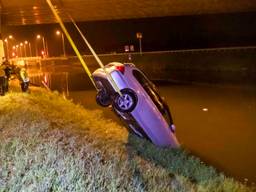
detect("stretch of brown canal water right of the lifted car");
top-left (160, 85), bottom-right (256, 182)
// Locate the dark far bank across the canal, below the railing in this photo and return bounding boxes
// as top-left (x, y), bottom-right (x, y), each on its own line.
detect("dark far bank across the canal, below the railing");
top-left (27, 48), bottom-right (256, 84)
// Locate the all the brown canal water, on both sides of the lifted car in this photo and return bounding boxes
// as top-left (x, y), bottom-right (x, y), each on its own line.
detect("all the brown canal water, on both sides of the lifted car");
top-left (31, 72), bottom-right (256, 183)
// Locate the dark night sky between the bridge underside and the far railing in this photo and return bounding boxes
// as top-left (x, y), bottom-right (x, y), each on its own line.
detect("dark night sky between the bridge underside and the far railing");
top-left (2, 12), bottom-right (256, 55)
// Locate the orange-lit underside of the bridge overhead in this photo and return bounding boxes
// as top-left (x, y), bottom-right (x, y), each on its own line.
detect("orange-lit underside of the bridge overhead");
top-left (0, 0), bottom-right (256, 25)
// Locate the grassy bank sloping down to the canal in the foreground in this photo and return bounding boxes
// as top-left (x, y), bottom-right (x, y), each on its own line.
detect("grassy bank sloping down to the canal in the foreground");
top-left (0, 86), bottom-right (255, 192)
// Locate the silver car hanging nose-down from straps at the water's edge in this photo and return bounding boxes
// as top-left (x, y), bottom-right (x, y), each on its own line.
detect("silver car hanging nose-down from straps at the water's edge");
top-left (92, 62), bottom-right (179, 148)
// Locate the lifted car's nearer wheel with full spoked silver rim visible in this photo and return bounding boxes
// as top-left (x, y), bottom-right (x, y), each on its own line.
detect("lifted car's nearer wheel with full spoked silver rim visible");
top-left (113, 88), bottom-right (138, 113)
